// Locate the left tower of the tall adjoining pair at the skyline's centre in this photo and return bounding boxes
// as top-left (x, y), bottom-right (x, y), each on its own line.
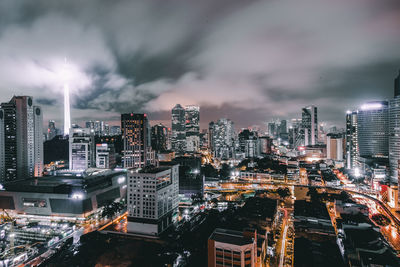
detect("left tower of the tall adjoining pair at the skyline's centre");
top-left (171, 104), bottom-right (186, 153)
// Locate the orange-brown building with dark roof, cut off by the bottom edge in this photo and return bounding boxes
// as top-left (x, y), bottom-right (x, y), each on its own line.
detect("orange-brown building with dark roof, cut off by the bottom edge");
top-left (208, 228), bottom-right (257, 267)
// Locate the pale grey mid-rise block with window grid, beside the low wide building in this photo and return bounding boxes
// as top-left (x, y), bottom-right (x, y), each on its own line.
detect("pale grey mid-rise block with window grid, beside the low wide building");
top-left (127, 165), bottom-right (179, 236)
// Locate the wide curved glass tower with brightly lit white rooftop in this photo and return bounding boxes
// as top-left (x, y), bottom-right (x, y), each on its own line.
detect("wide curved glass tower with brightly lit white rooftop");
top-left (357, 101), bottom-right (389, 158)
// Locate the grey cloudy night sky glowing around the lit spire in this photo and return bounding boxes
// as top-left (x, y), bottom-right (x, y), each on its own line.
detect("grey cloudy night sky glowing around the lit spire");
top-left (0, 0), bottom-right (400, 128)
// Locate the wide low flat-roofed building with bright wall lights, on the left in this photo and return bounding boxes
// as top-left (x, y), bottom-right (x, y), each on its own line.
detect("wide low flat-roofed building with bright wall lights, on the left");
top-left (0, 170), bottom-right (126, 219)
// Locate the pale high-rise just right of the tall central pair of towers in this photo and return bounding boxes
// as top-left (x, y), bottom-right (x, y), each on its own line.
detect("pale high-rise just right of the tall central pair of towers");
top-left (210, 118), bottom-right (236, 159)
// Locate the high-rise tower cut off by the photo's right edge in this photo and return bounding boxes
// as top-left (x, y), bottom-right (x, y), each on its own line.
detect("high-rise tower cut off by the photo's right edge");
top-left (389, 71), bottom-right (400, 182)
